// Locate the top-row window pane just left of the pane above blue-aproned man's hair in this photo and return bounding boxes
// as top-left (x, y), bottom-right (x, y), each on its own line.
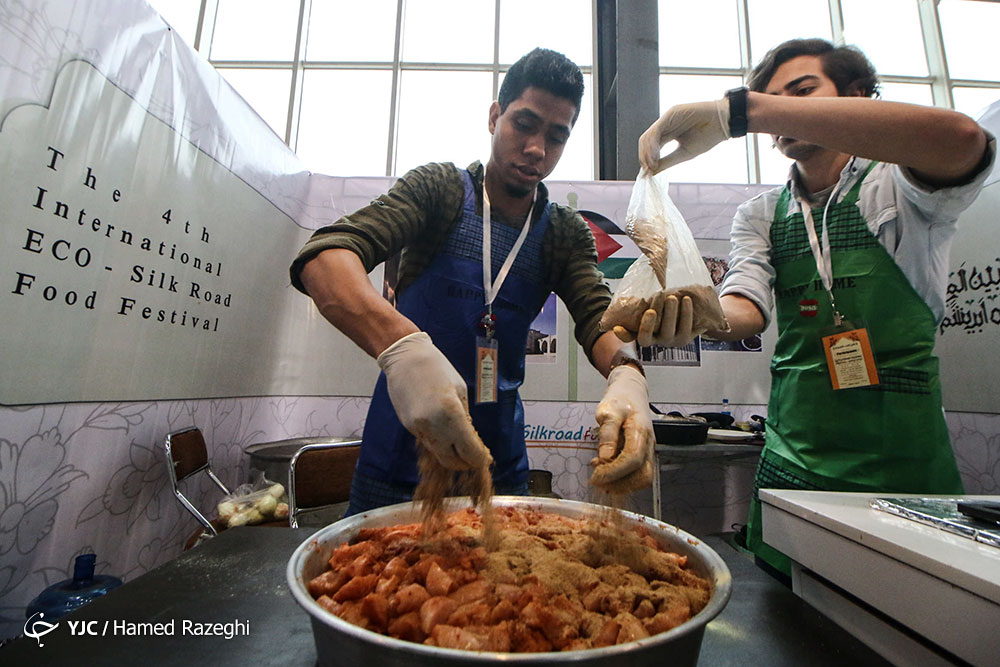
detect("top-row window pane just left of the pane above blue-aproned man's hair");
top-left (403, 0), bottom-right (495, 63)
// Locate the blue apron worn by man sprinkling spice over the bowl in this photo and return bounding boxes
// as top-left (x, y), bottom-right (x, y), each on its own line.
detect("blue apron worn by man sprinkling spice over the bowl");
top-left (357, 171), bottom-right (551, 496)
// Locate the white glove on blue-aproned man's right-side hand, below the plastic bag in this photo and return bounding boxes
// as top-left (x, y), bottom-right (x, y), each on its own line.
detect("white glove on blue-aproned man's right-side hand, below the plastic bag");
top-left (590, 364), bottom-right (655, 494)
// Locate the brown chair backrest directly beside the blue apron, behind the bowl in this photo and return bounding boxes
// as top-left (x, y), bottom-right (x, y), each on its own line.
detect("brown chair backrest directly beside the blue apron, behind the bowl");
top-left (288, 440), bottom-right (361, 528)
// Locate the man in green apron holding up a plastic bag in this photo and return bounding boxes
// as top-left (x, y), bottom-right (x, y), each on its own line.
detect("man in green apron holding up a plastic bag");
top-left (639, 39), bottom-right (996, 574)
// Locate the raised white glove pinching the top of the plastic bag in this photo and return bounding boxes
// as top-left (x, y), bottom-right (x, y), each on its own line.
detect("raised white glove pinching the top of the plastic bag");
top-left (639, 98), bottom-right (729, 174)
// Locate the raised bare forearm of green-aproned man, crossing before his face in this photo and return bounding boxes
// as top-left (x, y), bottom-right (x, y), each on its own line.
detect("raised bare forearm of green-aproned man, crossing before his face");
top-left (747, 93), bottom-right (986, 185)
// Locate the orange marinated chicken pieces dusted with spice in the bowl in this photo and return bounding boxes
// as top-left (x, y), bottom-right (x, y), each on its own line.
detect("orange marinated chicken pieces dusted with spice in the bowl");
top-left (308, 507), bottom-right (711, 653)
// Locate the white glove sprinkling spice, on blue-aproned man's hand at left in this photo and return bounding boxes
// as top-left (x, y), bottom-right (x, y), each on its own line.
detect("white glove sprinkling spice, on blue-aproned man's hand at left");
top-left (378, 331), bottom-right (493, 470)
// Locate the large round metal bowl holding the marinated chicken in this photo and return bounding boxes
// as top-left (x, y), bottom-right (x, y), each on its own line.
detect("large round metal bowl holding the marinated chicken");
top-left (287, 496), bottom-right (732, 667)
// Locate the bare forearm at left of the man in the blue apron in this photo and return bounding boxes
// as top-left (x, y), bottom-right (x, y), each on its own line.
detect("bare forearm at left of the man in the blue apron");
top-left (302, 248), bottom-right (419, 357)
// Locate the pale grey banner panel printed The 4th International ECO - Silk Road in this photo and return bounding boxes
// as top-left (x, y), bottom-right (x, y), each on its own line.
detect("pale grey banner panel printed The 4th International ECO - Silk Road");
top-left (0, 60), bottom-right (301, 403)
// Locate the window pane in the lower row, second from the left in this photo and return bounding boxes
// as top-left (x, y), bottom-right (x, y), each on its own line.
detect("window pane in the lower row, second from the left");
top-left (295, 70), bottom-right (392, 176)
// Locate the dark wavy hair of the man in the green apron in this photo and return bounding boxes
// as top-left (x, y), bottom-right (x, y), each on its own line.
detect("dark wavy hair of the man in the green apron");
top-left (747, 39), bottom-right (879, 97)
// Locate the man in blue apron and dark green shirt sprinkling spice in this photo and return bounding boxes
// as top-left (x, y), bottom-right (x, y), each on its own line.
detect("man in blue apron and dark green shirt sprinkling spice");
top-left (291, 49), bottom-right (653, 513)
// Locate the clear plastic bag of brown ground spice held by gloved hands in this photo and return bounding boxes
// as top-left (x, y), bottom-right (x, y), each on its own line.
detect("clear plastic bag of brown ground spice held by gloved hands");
top-left (601, 169), bottom-right (729, 334)
